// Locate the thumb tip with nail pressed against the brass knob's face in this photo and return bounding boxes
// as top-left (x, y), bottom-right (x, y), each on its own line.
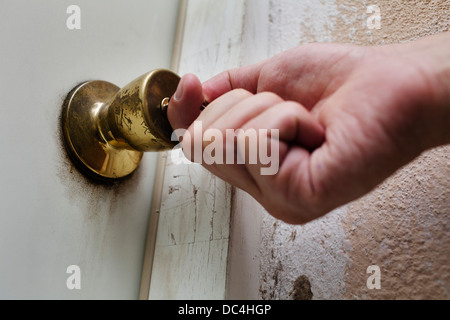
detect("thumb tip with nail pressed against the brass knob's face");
top-left (167, 74), bottom-right (204, 130)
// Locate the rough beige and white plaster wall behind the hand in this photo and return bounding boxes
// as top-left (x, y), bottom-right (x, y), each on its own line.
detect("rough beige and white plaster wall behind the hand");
top-left (253, 0), bottom-right (450, 299)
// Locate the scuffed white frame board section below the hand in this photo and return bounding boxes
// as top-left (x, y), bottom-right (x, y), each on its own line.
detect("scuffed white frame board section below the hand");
top-left (149, 149), bottom-right (231, 299)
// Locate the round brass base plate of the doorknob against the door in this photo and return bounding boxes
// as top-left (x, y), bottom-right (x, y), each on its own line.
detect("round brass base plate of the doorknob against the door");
top-left (61, 81), bottom-right (143, 180)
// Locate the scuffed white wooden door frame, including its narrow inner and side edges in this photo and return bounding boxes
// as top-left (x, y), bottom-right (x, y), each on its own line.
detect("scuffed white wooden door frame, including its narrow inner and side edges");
top-left (139, 0), bottom-right (262, 300)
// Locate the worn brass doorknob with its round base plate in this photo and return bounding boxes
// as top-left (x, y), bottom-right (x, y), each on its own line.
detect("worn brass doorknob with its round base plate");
top-left (61, 69), bottom-right (180, 180)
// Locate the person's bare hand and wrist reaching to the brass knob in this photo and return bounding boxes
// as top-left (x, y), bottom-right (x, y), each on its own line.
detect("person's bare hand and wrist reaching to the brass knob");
top-left (168, 31), bottom-right (450, 224)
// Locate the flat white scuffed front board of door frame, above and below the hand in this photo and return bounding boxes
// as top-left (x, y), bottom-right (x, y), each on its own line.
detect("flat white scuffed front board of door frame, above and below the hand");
top-left (149, 0), bottom-right (244, 299)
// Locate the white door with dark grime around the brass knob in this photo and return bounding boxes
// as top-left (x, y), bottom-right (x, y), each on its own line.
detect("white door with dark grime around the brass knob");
top-left (0, 0), bottom-right (178, 299)
